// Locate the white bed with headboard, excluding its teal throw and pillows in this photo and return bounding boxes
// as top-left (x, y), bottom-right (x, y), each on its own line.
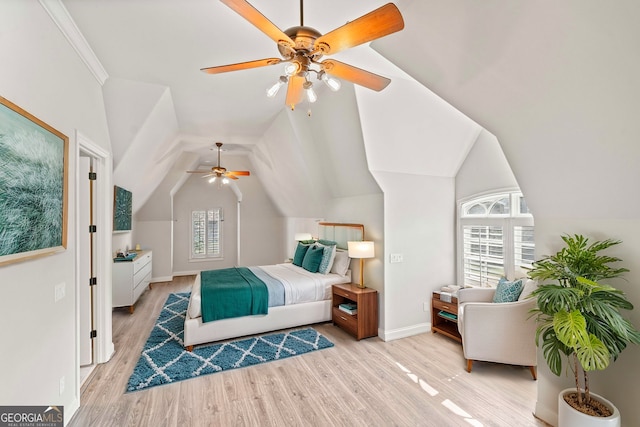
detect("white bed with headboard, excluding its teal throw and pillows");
top-left (184, 222), bottom-right (364, 351)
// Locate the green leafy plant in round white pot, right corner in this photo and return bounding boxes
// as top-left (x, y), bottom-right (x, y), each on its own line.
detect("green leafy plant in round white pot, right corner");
top-left (529, 235), bottom-right (640, 426)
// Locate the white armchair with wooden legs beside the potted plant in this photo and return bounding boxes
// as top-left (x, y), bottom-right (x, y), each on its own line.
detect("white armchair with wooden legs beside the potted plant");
top-left (458, 279), bottom-right (537, 380)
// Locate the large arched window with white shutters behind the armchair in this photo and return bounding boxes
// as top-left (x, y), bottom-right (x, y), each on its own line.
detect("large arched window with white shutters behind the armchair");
top-left (458, 192), bottom-right (535, 286)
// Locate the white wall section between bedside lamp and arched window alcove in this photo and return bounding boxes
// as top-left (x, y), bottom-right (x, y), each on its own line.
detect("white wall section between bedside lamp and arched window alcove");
top-left (373, 171), bottom-right (455, 340)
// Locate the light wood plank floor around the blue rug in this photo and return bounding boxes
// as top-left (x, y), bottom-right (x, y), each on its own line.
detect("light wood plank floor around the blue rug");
top-left (69, 276), bottom-right (545, 427)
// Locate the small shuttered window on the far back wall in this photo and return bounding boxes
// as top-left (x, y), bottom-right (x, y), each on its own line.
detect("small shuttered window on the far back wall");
top-left (191, 208), bottom-right (222, 259)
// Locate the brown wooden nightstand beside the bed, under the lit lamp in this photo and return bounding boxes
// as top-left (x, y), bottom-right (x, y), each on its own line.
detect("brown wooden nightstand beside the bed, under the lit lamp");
top-left (331, 283), bottom-right (378, 340)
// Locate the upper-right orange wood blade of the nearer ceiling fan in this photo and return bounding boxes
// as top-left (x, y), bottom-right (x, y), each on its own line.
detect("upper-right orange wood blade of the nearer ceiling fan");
top-left (315, 3), bottom-right (404, 55)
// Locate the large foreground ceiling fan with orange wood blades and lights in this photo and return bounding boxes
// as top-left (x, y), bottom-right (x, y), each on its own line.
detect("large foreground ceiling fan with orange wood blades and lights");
top-left (201, 0), bottom-right (404, 109)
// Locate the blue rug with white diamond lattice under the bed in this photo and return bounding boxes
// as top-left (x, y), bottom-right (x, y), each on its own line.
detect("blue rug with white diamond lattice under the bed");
top-left (127, 292), bottom-right (333, 392)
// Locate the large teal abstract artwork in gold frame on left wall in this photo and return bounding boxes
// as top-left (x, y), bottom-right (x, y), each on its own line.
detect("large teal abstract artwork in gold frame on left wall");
top-left (0, 97), bottom-right (69, 265)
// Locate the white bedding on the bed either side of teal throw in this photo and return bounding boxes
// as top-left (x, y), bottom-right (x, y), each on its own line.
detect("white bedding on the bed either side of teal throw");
top-left (188, 263), bottom-right (351, 319)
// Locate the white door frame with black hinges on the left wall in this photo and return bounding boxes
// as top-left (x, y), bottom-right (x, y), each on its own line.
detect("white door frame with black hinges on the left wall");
top-left (75, 130), bottom-right (115, 388)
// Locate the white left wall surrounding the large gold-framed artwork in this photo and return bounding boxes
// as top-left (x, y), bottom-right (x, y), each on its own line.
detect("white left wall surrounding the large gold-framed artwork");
top-left (0, 0), bottom-right (110, 421)
